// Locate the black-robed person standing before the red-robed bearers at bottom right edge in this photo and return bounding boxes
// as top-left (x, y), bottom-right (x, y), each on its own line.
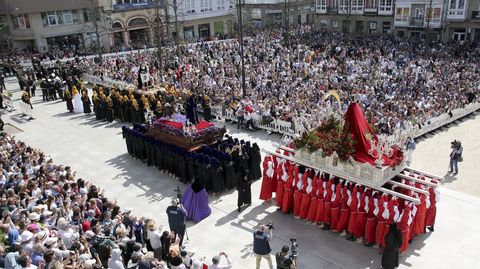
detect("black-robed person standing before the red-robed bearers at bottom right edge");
top-left (382, 222), bottom-right (403, 269)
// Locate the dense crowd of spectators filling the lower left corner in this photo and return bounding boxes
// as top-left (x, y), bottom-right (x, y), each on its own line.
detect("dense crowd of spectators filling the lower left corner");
top-left (0, 133), bottom-right (232, 269)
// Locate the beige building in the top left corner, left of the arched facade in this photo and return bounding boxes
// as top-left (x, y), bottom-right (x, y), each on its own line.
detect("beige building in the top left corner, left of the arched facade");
top-left (0, 0), bottom-right (108, 51)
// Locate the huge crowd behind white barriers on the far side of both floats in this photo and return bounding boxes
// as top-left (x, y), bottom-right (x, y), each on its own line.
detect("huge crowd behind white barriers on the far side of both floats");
top-left (62, 27), bottom-right (480, 133)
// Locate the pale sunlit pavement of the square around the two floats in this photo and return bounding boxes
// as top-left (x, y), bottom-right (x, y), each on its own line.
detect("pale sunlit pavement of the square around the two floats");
top-left (3, 80), bottom-right (480, 269)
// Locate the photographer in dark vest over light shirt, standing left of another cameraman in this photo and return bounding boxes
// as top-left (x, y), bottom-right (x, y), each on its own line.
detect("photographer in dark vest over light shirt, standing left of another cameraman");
top-left (253, 224), bottom-right (273, 269)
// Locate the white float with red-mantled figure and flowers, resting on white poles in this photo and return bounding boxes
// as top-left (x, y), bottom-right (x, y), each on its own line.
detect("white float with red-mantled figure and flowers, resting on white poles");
top-left (262, 96), bottom-right (442, 204)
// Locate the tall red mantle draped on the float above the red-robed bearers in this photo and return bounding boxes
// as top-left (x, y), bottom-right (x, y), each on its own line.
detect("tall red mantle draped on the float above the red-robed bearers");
top-left (343, 103), bottom-right (403, 166)
